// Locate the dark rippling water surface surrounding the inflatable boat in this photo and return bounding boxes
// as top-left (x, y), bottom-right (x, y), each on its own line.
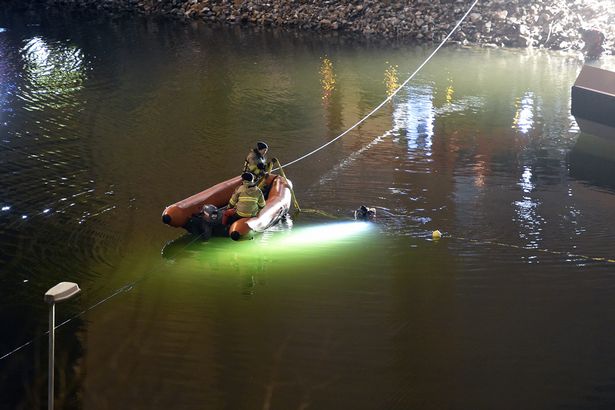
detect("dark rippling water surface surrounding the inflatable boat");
top-left (0, 7), bottom-right (615, 409)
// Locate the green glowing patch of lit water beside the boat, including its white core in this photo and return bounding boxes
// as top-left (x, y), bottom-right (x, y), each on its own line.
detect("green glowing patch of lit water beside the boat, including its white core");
top-left (156, 222), bottom-right (382, 303)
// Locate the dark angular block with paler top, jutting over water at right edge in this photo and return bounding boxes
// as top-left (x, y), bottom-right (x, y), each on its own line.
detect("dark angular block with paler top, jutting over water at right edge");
top-left (571, 65), bottom-right (615, 138)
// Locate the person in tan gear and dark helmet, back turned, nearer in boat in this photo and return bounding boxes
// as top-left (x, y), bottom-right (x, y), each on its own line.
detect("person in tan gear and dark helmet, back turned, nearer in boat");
top-left (222, 172), bottom-right (265, 225)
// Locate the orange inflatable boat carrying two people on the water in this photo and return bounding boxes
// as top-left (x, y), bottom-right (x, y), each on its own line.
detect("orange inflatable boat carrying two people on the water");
top-left (162, 174), bottom-right (292, 240)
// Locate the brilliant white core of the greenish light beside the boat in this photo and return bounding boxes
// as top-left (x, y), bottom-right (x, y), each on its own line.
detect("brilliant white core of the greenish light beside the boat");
top-left (284, 222), bottom-right (370, 245)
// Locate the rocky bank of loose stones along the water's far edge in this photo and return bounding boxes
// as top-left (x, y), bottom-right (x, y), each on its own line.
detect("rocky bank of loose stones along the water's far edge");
top-left (9, 0), bottom-right (615, 55)
